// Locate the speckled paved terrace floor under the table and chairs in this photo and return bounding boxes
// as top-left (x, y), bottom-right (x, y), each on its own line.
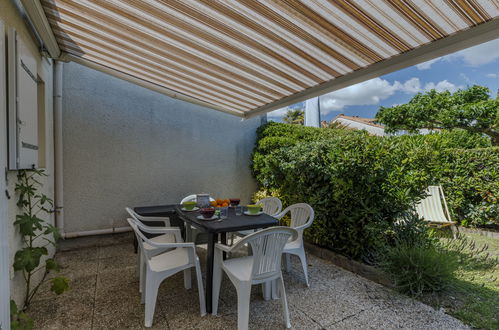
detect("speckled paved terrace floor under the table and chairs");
top-left (29, 233), bottom-right (467, 330)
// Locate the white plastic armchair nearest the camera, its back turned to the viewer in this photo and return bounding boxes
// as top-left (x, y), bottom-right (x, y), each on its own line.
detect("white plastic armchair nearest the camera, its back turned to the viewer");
top-left (213, 227), bottom-right (298, 330)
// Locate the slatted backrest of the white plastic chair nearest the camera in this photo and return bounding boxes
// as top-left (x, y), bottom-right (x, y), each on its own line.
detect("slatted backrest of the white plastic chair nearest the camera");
top-left (237, 227), bottom-right (298, 281)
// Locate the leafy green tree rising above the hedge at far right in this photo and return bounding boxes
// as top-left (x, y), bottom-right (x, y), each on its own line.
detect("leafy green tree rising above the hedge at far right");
top-left (376, 85), bottom-right (499, 146)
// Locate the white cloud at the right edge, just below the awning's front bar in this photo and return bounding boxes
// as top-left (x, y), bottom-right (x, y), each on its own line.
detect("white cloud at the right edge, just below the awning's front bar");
top-left (416, 39), bottom-right (499, 70)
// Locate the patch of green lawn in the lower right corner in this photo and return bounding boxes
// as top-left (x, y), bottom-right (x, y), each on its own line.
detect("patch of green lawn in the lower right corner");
top-left (421, 234), bottom-right (499, 329)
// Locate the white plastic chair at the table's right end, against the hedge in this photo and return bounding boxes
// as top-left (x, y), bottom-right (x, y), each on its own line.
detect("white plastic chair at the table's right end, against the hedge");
top-left (276, 203), bottom-right (314, 286)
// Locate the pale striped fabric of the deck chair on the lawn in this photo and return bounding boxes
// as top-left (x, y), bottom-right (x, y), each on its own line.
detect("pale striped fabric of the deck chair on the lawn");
top-left (416, 186), bottom-right (451, 222)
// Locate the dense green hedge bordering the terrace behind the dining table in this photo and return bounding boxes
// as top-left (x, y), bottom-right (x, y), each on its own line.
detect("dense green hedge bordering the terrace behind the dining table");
top-left (252, 123), bottom-right (497, 259)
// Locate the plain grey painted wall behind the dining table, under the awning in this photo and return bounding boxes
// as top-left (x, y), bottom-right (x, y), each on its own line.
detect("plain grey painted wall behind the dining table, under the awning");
top-left (63, 63), bottom-right (262, 233)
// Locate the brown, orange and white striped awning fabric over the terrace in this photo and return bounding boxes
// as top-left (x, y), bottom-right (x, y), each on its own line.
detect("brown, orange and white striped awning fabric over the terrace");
top-left (41, 0), bottom-right (499, 117)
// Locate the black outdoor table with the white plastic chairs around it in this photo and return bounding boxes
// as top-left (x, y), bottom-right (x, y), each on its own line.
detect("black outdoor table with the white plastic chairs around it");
top-left (127, 195), bottom-right (314, 329)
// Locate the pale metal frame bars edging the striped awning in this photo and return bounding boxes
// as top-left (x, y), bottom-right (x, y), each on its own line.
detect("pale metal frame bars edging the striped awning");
top-left (20, 0), bottom-right (499, 118)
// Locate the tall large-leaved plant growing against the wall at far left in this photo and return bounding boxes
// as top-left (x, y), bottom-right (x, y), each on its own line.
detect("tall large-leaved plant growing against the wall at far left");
top-left (11, 170), bottom-right (69, 329)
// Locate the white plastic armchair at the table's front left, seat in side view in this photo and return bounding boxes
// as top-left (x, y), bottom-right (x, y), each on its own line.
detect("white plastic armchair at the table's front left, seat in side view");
top-left (127, 218), bottom-right (206, 327)
